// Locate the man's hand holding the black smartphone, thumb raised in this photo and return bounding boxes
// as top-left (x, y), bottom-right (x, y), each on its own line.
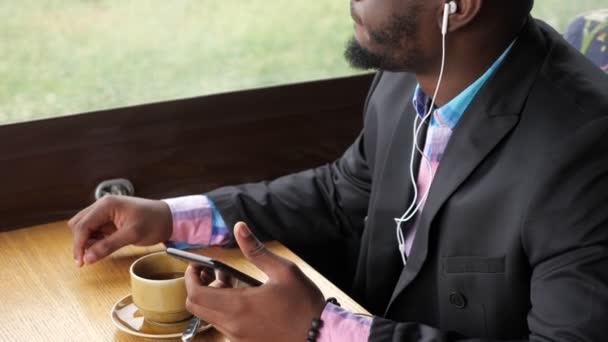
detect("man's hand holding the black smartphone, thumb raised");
top-left (185, 223), bottom-right (325, 342)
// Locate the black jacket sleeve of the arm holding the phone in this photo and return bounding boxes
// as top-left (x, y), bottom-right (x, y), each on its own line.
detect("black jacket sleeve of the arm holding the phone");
top-left (370, 117), bottom-right (608, 342)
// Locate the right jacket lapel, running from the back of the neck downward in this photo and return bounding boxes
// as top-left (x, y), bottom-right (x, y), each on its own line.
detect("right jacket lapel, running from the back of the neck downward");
top-left (386, 16), bottom-right (544, 314)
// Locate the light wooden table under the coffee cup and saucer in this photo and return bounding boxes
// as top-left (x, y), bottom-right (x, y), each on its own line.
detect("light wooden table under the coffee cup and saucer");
top-left (0, 222), bottom-right (367, 342)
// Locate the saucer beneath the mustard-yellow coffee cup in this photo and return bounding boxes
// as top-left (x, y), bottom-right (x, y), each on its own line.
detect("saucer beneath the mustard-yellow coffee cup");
top-left (110, 295), bottom-right (212, 339)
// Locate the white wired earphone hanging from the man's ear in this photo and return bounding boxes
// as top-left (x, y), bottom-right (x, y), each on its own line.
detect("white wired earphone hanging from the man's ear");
top-left (395, 1), bottom-right (458, 266)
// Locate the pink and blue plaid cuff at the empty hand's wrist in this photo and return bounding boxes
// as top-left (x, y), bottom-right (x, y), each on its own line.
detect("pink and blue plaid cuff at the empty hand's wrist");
top-left (163, 195), bottom-right (230, 248)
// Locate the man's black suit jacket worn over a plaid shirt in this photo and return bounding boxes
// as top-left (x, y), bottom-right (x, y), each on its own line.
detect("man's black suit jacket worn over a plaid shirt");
top-left (210, 20), bottom-right (608, 341)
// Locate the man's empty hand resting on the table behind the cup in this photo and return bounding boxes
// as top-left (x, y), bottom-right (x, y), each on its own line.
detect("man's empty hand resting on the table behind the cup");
top-left (68, 196), bottom-right (173, 266)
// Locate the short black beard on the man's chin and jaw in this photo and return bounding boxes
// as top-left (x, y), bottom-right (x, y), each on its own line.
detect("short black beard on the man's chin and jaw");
top-left (344, 5), bottom-right (421, 71)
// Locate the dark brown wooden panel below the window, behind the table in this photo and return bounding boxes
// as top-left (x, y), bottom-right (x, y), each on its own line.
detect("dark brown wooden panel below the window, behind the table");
top-left (0, 74), bottom-right (373, 231)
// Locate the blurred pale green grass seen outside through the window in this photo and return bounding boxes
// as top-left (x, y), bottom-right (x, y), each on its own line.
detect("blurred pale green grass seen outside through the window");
top-left (0, 0), bottom-right (605, 124)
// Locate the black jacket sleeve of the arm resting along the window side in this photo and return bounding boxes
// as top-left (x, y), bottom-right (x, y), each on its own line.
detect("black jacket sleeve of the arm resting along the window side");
top-left (207, 72), bottom-right (382, 248)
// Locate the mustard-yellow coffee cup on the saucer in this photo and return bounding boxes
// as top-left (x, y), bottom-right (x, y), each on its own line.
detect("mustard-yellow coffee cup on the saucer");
top-left (130, 252), bottom-right (192, 323)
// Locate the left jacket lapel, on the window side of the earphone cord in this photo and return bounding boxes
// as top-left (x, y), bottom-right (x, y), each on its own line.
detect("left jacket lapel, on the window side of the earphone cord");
top-left (365, 73), bottom-right (416, 312)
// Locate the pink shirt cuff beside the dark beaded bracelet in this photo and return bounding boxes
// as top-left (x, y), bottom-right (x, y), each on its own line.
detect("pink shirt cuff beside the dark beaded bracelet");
top-left (317, 303), bottom-right (372, 342)
